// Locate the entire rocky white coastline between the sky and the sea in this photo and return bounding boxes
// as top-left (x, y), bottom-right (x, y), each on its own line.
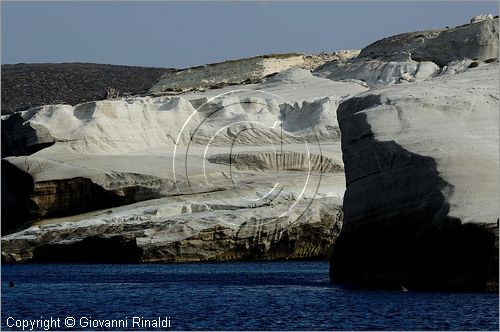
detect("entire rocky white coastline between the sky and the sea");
top-left (2, 16), bottom-right (500, 291)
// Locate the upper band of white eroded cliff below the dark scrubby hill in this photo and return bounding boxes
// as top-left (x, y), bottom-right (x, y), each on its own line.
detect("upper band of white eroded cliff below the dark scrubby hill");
top-left (2, 69), bottom-right (366, 157)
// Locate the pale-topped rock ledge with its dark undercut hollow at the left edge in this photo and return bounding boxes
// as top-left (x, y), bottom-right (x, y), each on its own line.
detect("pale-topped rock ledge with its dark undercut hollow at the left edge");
top-left (2, 157), bottom-right (170, 233)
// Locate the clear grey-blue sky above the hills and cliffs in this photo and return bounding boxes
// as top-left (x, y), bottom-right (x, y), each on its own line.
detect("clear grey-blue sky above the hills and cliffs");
top-left (1, 1), bottom-right (498, 68)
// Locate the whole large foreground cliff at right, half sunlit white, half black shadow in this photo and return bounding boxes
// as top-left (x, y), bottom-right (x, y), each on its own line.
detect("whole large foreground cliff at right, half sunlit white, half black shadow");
top-left (330, 61), bottom-right (499, 290)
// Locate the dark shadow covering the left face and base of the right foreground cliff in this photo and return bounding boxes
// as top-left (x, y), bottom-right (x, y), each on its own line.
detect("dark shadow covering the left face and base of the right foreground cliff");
top-left (330, 95), bottom-right (498, 290)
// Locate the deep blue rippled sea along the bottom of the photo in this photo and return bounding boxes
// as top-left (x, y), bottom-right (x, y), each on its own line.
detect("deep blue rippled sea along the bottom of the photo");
top-left (1, 262), bottom-right (499, 331)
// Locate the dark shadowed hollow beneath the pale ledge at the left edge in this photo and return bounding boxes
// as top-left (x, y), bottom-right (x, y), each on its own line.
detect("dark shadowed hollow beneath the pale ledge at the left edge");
top-left (1, 159), bottom-right (162, 235)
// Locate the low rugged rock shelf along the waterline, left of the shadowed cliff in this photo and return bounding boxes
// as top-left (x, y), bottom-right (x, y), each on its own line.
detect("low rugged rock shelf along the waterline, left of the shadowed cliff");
top-left (2, 199), bottom-right (342, 263)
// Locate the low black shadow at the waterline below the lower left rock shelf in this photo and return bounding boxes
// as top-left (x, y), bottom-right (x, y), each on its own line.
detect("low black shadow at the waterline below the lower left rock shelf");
top-left (32, 235), bottom-right (142, 263)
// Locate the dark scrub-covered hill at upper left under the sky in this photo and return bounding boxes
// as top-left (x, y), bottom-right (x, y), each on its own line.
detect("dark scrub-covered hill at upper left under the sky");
top-left (2, 63), bottom-right (168, 114)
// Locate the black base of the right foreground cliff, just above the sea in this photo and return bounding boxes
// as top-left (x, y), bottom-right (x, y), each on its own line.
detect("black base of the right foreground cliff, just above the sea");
top-left (330, 224), bottom-right (499, 291)
